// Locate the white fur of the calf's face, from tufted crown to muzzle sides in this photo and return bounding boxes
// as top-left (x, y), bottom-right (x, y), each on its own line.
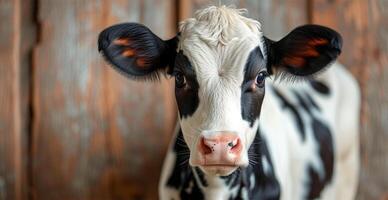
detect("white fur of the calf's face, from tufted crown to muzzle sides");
top-left (179, 6), bottom-right (263, 170)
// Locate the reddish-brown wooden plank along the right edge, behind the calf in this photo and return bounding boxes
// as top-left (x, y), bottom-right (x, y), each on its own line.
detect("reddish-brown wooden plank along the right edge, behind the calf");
top-left (312, 0), bottom-right (388, 199)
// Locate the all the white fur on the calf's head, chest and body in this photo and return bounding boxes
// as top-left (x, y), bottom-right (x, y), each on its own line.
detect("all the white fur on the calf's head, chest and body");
top-left (159, 7), bottom-right (360, 200)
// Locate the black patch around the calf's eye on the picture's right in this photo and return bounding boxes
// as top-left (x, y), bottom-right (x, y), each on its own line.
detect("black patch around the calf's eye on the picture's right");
top-left (241, 47), bottom-right (265, 127)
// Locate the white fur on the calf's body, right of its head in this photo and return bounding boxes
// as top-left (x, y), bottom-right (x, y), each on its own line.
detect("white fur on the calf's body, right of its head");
top-left (260, 63), bottom-right (360, 200)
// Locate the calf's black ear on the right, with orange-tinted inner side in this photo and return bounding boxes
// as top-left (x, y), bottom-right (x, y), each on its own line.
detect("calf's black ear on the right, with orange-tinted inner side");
top-left (266, 25), bottom-right (342, 76)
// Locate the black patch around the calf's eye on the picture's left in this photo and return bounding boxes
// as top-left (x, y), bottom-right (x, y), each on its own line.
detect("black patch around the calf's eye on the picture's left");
top-left (173, 51), bottom-right (199, 118)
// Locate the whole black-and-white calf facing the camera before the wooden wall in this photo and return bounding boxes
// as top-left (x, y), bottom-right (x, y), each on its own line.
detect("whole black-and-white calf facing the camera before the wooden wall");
top-left (98, 6), bottom-right (360, 200)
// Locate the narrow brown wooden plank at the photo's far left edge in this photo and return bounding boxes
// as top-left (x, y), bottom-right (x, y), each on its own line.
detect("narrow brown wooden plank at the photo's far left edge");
top-left (0, 1), bottom-right (22, 199)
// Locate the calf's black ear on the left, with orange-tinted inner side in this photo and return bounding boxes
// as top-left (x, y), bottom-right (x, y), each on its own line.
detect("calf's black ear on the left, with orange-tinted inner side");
top-left (98, 23), bottom-right (177, 79)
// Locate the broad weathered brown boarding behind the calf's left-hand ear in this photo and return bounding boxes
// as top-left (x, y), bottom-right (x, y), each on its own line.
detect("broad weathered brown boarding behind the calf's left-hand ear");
top-left (32, 0), bottom-right (176, 199)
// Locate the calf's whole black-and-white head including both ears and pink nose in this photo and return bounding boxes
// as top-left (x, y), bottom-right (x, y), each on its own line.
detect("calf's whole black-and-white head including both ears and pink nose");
top-left (98, 7), bottom-right (342, 176)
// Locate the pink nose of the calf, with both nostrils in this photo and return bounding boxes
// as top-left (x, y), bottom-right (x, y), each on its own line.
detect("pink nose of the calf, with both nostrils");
top-left (198, 132), bottom-right (242, 165)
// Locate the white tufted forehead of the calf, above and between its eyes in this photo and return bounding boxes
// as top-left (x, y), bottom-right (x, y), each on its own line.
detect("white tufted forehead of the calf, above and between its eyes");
top-left (178, 6), bottom-right (265, 82)
